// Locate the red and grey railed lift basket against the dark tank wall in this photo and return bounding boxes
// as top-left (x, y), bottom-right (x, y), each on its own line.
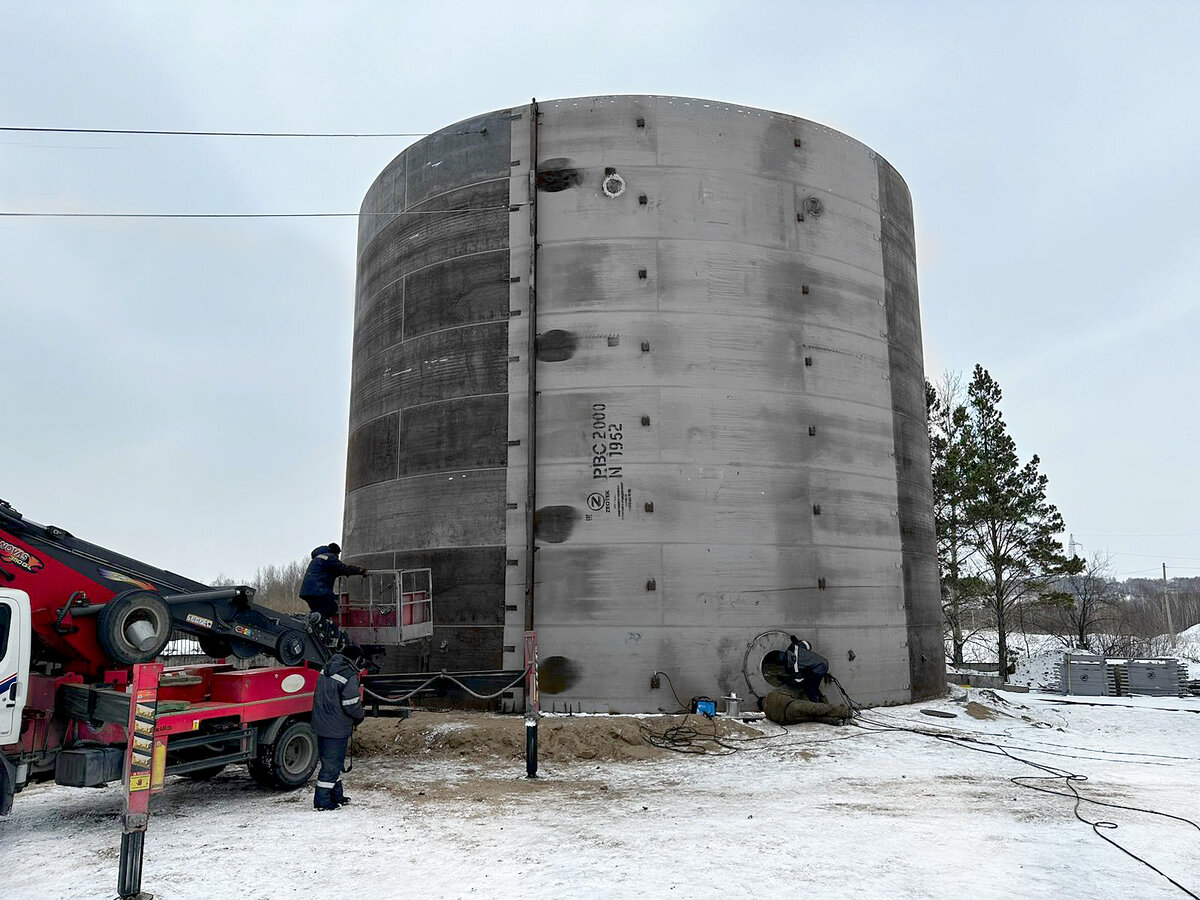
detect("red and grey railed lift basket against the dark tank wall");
top-left (337, 569), bottom-right (433, 647)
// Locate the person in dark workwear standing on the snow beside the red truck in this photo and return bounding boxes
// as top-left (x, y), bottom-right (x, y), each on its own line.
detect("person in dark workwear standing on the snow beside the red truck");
top-left (312, 653), bottom-right (366, 809)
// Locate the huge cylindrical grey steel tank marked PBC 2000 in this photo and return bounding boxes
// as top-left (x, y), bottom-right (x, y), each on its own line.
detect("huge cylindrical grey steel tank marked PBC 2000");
top-left (343, 96), bottom-right (944, 712)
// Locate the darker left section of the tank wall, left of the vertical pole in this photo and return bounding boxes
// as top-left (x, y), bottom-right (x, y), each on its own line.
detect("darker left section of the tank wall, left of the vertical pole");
top-left (343, 110), bottom-right (510, 671)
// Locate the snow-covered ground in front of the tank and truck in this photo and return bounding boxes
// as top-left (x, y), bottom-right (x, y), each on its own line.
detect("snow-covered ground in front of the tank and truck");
top-left (0, 689), bottom-right (1200, 900)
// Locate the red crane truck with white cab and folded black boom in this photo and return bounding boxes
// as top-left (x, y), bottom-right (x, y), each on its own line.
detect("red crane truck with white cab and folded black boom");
top-left (0, 500), bottom-right (347, 815)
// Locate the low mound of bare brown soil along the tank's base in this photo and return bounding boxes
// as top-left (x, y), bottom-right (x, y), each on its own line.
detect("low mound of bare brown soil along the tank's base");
top-left (353, 710), bottom-right (760, 762)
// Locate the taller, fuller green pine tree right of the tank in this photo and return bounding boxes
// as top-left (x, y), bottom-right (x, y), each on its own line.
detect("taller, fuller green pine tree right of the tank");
top-left (962, 365), bottom-right (1084, 680)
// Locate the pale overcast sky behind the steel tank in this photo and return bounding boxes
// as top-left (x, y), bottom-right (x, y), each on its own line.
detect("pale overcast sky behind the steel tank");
top-left (0, 0), bottom-right (1200, 580)
